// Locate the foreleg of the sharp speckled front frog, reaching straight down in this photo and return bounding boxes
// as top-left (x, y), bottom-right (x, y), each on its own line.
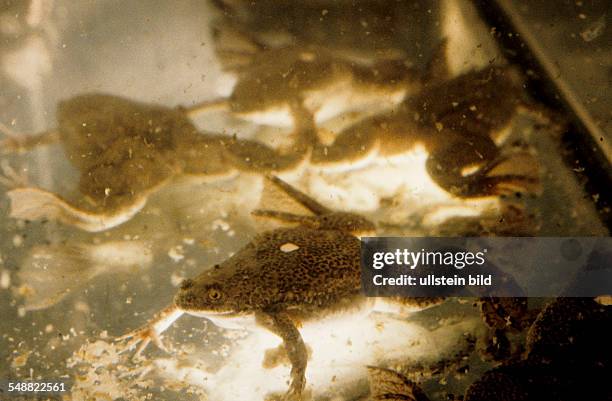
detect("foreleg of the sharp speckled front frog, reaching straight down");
top-left (256, 311), bottom-right (308, 401)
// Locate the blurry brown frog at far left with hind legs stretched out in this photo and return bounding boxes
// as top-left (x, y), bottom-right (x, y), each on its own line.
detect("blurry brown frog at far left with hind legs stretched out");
top-left (0, 94), bottom-right (314, 232)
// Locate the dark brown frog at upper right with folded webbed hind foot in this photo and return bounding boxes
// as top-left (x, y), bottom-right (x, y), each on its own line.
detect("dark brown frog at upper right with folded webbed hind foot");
top-left (310, 66), bottom-right (546, 198)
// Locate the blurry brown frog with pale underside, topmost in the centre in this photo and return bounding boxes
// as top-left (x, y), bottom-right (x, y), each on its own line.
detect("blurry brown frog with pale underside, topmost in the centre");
top-left (194, 42), bottom-right (420, 126)
